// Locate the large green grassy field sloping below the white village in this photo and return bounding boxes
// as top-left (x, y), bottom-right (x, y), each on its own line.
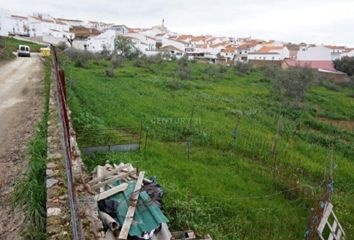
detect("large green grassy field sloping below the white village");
top-left (62, 53), bottom-right (354, 239)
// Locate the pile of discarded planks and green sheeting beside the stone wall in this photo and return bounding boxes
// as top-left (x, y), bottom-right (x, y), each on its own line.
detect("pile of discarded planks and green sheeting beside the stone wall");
top-left (88, 163), bottom-right (211, 240)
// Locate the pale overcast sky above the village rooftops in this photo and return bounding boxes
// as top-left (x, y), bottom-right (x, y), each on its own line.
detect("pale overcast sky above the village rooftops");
top-left (0, 0), bottom-right (354, 47)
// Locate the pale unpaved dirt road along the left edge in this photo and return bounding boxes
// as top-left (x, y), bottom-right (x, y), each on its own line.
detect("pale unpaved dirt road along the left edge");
top-left (0, 54), bottom-right (44, 239)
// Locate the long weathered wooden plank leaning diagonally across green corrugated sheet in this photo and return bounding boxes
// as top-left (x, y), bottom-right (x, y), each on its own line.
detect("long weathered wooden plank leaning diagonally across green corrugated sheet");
top-left (118, 172), bottom-right (144, 240)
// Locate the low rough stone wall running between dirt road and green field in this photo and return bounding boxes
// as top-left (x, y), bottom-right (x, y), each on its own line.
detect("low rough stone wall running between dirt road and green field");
top-left (46, 62), bottom-right (104, 240)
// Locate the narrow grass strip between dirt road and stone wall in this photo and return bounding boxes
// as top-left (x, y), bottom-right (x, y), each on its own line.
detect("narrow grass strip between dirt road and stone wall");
top-left (13, 59), bottom-right (51, 239)
